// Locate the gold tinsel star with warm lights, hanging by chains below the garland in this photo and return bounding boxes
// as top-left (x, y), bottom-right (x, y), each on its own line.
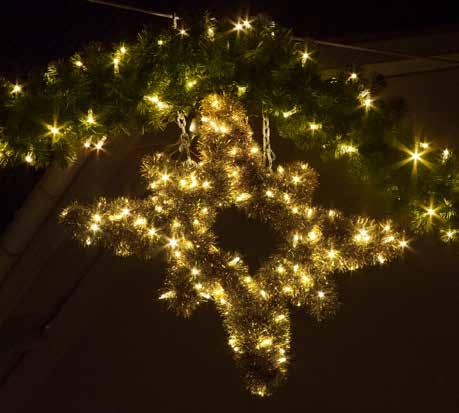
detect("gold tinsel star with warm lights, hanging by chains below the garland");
top-left (61, 95), bottom-right (407, 396)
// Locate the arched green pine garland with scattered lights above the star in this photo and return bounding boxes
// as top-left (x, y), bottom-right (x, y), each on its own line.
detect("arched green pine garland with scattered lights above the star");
top-left (0, 17), bottom-right (459, 241)
